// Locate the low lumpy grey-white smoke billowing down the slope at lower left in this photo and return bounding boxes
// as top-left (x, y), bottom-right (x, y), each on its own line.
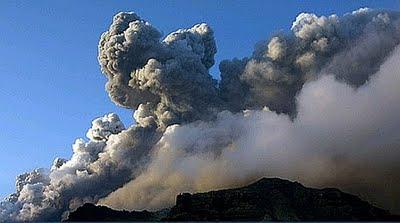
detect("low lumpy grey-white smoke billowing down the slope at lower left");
top-left (0, 114), bottom-right (159, 221)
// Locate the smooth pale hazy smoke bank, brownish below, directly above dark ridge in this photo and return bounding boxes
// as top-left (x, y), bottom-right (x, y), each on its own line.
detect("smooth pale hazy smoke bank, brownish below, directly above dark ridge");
top-left (101, 45), bottom-right (400, 211)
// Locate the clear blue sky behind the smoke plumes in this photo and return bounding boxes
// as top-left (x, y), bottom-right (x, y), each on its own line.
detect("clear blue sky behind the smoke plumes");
top-left (0, 0), bottom-right (400, 197)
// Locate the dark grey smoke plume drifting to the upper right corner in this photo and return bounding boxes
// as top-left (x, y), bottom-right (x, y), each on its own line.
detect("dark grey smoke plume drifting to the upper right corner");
top-left (220, 8), bottom-right (400, 115)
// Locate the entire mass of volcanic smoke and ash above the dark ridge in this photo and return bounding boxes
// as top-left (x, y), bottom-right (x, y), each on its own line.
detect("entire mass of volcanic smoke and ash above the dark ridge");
top-left (0, 6), bottom-right (400, 221)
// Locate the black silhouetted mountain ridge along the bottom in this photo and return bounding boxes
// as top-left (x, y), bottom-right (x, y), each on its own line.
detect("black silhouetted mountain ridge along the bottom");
top-left (67, 178), bottom-right (400, 221)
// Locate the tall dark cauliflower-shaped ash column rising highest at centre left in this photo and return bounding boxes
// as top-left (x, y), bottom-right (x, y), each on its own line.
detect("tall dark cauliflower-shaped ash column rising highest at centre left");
top-left (99, 13), bottom-right (220, 127)
